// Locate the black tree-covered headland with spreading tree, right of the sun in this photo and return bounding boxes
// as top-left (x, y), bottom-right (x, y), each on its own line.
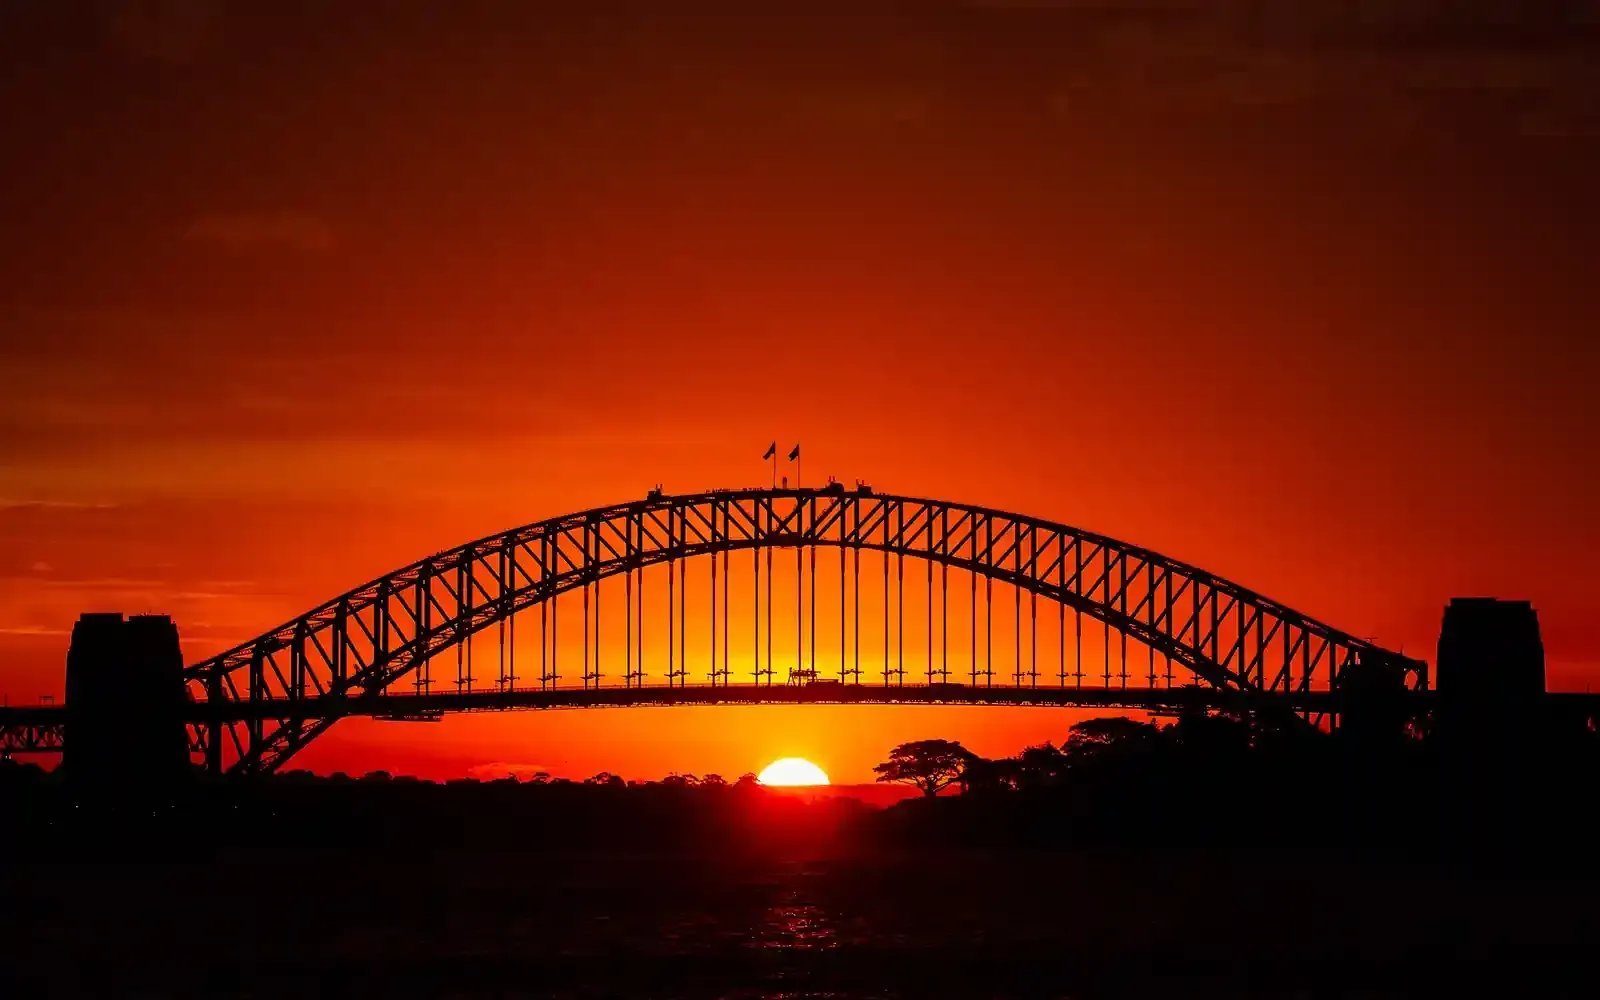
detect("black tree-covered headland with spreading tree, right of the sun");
top-left (875, 714), bottom-right (1600, 853)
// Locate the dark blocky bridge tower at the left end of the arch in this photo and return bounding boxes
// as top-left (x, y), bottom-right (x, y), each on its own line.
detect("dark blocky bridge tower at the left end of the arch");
top-left (61, 614), bottom-right (189, 794)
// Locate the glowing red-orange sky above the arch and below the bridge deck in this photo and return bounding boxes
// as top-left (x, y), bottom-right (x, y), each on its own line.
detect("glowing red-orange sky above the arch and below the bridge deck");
top-left (0, 0), bottom-right (1600, 781)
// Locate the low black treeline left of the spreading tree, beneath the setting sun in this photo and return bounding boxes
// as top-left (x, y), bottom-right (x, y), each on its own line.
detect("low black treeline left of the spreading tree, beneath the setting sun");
top-left (0, 763), bottom-right (872, 856)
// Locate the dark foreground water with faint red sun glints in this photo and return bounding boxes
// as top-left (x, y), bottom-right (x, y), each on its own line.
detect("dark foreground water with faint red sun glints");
top-left (0, 843), bottom-right (1597, 998)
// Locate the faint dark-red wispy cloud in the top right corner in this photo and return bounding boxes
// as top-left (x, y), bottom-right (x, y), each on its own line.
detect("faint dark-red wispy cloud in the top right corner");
top-left (1027, 0), bottom-right (1600, 134)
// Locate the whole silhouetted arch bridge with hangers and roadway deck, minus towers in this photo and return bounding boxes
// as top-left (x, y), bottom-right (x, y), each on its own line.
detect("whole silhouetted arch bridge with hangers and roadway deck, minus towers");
top-left (0, 483), bottom-right (1452, 774)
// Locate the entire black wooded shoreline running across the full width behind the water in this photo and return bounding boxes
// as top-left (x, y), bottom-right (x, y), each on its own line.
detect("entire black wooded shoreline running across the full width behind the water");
top-left (9, 714), bottom-right (1600, 854)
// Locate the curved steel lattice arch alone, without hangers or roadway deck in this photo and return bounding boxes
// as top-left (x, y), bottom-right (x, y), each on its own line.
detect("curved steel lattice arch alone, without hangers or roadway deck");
top-left (184, 485), bottom-right (1427, 773)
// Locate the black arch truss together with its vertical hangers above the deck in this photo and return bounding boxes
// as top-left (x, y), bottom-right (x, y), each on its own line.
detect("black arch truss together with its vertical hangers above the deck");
top-left (184, 485), bottom-right (1427, 773)
